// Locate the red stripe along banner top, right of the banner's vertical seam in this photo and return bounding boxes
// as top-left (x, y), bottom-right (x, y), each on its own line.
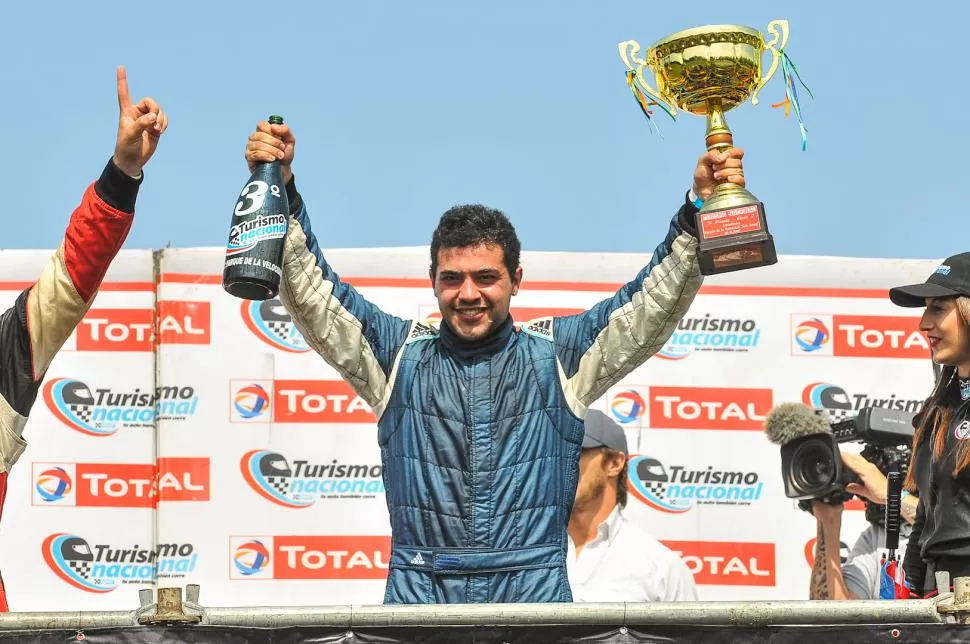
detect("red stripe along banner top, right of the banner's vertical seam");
top-left (160, 273), bottom-right (889, 299)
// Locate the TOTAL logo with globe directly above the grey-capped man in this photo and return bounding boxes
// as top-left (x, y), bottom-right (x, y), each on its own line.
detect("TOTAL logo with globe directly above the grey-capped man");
top-left (607, 385), bottom-right (773, 431)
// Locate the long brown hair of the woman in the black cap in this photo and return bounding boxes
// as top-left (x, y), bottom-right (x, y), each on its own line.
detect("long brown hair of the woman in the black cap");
top-left (905, 297), bottom-right (970, 492)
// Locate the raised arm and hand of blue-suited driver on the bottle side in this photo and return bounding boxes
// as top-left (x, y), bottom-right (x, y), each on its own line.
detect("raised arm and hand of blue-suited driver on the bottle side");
top-left (246, 121), bottom-right (416, 418)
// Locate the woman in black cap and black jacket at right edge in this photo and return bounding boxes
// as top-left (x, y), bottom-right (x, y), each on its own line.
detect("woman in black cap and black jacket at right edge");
top-left (889, 253), bottom-right (970, 595)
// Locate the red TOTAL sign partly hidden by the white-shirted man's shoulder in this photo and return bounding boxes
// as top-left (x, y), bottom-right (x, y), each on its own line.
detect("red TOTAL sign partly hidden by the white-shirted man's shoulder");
top-left (663, 541), bottom-right (775, 586)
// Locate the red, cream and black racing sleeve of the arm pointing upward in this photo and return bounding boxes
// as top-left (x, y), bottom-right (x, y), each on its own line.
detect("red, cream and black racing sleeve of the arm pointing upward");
top-left (0, 161), bottom-right (144, 611)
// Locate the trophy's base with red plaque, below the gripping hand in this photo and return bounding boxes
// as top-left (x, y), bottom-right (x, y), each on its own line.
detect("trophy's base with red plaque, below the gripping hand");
top-left (696, 183), bottom-right (778, 275)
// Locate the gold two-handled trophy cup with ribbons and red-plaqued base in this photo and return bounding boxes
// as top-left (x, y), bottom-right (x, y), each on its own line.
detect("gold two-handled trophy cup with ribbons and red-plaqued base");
top-left (619, 20), bottom-right (792, 275)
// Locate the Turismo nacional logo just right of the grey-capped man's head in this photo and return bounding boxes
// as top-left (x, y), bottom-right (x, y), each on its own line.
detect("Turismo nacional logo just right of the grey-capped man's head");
top-left (627, 454), bottom-right (764, 514)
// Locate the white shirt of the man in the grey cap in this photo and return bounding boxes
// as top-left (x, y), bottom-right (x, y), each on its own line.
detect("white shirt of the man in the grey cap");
top-left (566, 505), bottom-right (697, 602)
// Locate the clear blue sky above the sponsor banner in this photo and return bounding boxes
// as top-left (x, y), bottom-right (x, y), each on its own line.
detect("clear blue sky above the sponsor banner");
top-left (0, 0), bottom-right (970, 258)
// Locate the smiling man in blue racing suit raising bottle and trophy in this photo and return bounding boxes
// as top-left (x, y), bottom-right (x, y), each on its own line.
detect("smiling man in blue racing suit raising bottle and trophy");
top-left (246, 121), bottom-right (744, 604)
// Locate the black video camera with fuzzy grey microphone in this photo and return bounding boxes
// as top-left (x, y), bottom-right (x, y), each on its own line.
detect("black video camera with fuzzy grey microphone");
top-left (765, 403), bottom-right (914, 522)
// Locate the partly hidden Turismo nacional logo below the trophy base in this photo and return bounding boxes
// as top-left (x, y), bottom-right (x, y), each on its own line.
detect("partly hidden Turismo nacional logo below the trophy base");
top-left (657, 313), bottom-right (761, 360)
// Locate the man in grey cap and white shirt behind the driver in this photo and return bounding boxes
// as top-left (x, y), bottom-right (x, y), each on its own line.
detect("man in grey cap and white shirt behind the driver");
top-left (566, 409), bottom-right (697, 602)
